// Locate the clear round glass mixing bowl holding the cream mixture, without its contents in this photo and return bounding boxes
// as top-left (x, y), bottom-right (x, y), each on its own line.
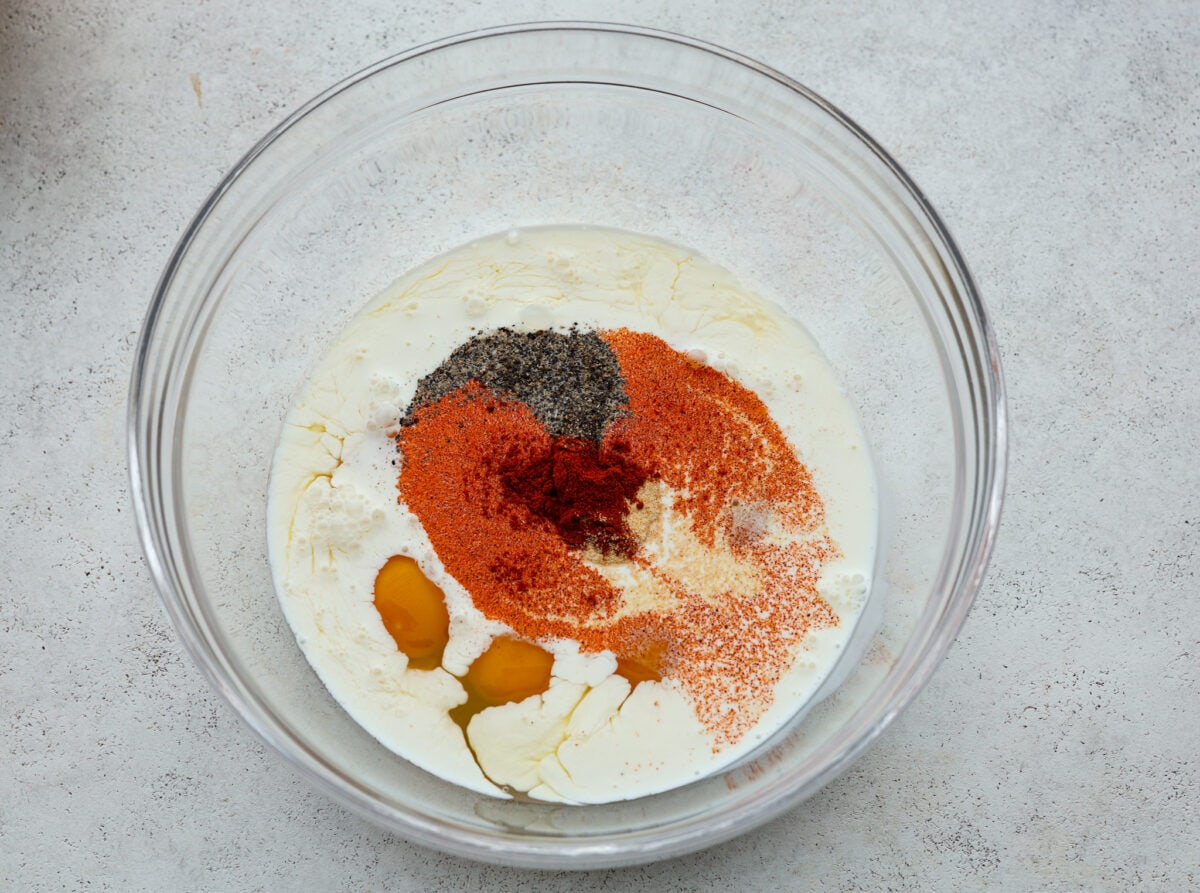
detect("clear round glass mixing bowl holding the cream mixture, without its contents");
top-left (128, 24), bottom-right (1006, 868)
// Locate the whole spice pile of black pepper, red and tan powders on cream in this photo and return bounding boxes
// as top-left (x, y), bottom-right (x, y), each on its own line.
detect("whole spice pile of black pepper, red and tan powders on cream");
top-left (396, 329), bottom-right (838, 749)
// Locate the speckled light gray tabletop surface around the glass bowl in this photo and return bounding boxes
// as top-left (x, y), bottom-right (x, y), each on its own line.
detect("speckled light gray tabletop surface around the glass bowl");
top-left (0, 0), bottom-right (1200, 891)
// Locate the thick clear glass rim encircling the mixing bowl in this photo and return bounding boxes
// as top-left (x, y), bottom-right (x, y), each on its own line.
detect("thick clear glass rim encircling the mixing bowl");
top-left (126, 22), bottom-right (1008, 869)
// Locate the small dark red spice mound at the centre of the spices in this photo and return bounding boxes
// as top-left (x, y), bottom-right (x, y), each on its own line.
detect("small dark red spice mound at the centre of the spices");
top-left (498, 437), bottom-right (648, 558)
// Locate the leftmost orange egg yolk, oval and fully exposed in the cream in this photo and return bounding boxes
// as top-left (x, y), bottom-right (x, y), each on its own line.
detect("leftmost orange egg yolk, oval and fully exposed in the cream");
top-left (374, 555), bottom-right (450, 670)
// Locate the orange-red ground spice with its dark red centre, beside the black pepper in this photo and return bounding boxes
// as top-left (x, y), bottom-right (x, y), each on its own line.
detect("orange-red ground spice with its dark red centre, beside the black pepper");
top-left (397, 329), bottom-right (838, 750)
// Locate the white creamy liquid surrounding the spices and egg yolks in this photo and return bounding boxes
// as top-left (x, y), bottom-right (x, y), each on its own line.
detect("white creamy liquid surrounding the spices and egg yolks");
top-left (269, 227), bottom-right (877, 803)
